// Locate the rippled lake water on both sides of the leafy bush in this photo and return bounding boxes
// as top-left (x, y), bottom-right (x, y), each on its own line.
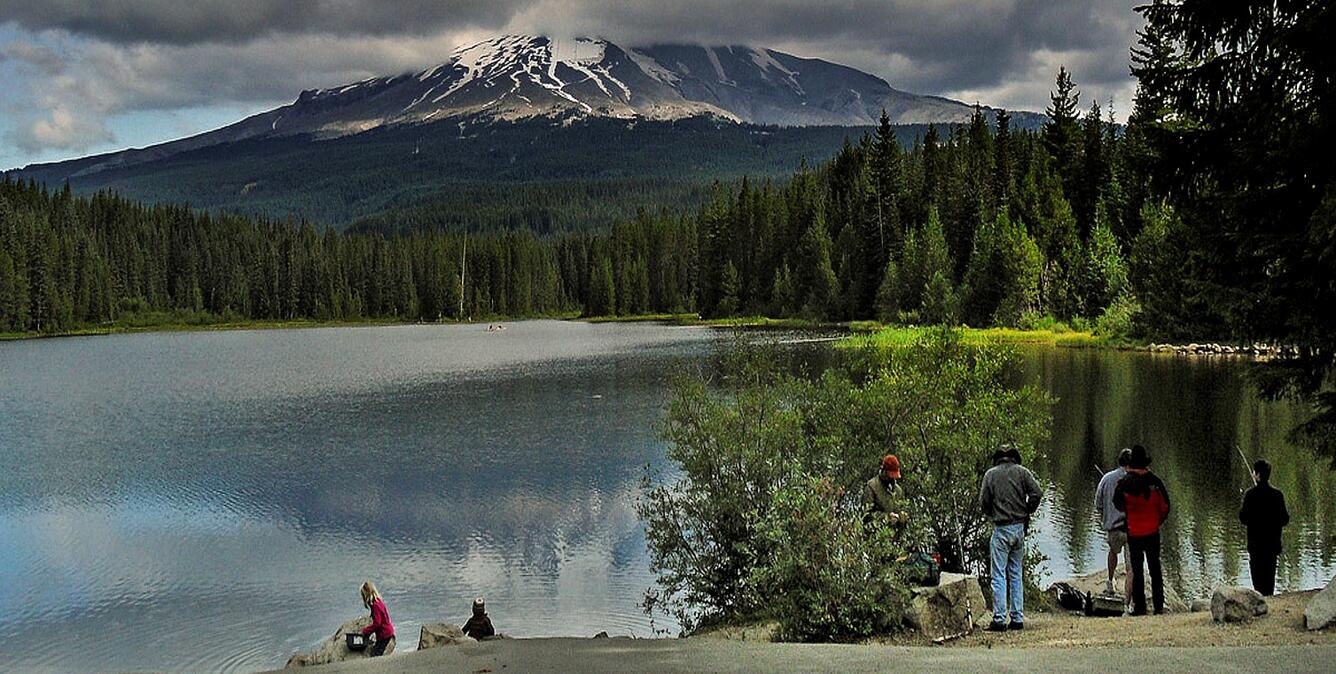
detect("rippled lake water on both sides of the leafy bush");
top-left (0, 321), bottom-right (1336, 670)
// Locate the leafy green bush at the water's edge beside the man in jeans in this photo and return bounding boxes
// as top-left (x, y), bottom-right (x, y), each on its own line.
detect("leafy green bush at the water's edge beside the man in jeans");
top-left (639, 329), bottom-right (1049, 639)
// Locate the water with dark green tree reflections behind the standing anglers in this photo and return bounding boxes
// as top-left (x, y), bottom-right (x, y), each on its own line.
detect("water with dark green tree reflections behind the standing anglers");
top-left (1022, 349), bottom-right (1336, 596)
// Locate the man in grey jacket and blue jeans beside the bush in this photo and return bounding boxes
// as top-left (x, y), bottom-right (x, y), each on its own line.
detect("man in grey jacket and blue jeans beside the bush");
top-left (979, 445), bottom-right (1043, 631)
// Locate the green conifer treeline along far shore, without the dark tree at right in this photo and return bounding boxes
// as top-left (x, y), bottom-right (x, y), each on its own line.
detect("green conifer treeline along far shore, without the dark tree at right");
top-left (0, 72), bottom-right (1142, 332)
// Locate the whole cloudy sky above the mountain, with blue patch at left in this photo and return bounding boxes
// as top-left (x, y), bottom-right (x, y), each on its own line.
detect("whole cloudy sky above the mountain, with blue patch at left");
top-left (0, 0), bottom-right (1141, 169)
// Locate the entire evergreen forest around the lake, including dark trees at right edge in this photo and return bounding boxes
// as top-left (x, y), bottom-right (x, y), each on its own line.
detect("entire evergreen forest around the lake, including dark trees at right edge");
top-left (0, 1), bottom-right (1336, 425)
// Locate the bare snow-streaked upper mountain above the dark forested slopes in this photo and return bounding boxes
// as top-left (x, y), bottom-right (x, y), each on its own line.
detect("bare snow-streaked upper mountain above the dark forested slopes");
top-left (20, 35), bottom-right (1043, 177)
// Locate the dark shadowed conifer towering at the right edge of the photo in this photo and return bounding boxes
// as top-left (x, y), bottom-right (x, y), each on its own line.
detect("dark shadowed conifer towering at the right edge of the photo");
top-left (1128, 0), bottom-right (1336, 457)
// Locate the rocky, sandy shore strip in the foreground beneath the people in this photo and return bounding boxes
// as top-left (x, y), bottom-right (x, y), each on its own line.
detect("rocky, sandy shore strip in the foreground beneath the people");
top-left (276, 568), bottom-right (1336, 671)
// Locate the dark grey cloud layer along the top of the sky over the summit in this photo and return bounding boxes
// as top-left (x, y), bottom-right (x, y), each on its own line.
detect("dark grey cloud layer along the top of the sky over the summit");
top-left (0, 0), bottom-right (1137, 92)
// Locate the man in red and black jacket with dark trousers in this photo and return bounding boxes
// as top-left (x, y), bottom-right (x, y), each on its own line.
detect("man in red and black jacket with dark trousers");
top-left (1113, 445), bottom-right (1169, 615)
